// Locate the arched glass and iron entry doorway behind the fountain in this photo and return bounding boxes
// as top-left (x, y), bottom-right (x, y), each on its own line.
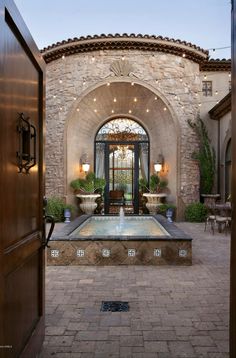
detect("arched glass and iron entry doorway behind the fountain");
top-left (94, 117), bottom-right (149, 214)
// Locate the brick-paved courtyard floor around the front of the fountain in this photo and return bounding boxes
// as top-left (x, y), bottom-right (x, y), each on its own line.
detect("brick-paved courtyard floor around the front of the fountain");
top-left (40, 223), bottom-right (230, 358)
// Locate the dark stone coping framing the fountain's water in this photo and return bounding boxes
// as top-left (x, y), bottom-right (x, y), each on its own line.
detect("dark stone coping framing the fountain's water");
top-left (50, 215), bottom-right (192, 241)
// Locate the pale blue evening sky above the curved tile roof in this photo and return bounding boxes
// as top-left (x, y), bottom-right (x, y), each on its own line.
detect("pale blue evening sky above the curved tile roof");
top-left (15, 0), bottom-right (231, 59)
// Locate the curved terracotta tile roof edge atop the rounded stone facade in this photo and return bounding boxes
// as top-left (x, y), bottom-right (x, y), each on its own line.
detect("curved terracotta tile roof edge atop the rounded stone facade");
top-left (41, 33), bottom-right (208, 63)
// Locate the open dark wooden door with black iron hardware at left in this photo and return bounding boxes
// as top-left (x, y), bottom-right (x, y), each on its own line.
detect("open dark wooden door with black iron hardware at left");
top-left (0, 0), bottom-right (44, 358)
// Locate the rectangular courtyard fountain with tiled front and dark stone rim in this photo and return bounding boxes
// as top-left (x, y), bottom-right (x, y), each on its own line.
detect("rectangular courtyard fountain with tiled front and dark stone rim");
top-left (47, 215), bottom-right (192, 265)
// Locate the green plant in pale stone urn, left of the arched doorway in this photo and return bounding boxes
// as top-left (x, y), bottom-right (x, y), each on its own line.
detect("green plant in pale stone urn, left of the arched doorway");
top-left (70, 173), bottom-right (106, 214)
